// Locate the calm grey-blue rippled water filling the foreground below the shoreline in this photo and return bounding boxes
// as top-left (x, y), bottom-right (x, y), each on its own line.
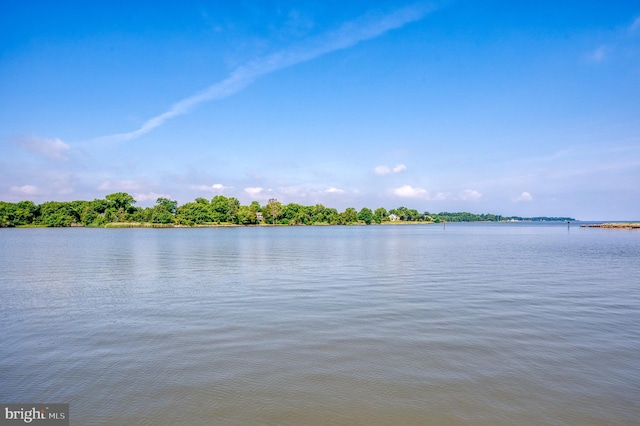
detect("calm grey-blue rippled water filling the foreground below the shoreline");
top-left (0, 224), bottom-right (640, 425)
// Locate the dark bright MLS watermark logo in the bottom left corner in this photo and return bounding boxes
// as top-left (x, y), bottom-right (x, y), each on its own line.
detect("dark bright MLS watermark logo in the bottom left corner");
top-left (0, 404), bottom-right (69, 426)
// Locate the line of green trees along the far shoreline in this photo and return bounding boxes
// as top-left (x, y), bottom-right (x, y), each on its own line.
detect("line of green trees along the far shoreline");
top-left (0, 192), bottom-right (573, 227)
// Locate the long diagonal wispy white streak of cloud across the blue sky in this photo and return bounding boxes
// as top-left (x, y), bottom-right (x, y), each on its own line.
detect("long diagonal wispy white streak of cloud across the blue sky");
top-left (92, 5), bottom-right (430, 142)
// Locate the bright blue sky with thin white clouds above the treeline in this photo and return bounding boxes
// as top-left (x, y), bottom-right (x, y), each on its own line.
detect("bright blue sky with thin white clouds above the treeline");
top-left (0, 0), bottom-right (640, 220)
